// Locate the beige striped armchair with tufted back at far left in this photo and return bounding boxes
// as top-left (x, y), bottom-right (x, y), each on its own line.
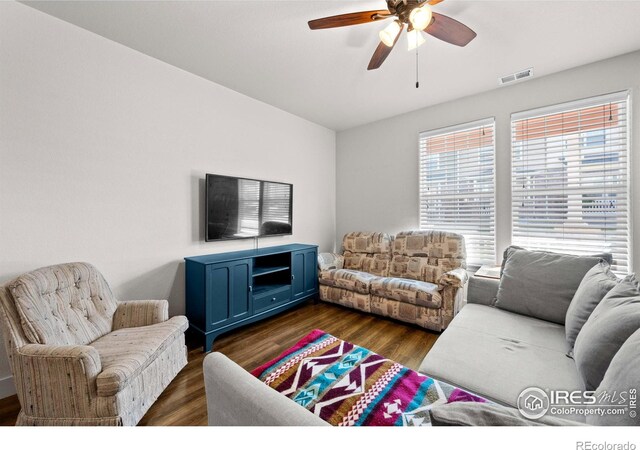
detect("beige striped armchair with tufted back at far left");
top-left (0, 263), bottom-right (188, 425)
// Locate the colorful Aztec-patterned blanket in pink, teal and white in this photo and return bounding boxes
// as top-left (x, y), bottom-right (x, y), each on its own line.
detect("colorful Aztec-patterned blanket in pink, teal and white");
top-left (251, 330), bottom-right (487, 426)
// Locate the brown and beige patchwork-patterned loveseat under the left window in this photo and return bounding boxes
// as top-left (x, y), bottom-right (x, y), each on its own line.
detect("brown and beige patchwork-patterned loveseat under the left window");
top-left (318, 231), bottom-right (467, 331)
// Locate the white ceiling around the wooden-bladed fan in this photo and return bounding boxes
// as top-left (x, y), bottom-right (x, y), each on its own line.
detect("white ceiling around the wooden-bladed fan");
top-left (22, 0), bottom-right (640, 130)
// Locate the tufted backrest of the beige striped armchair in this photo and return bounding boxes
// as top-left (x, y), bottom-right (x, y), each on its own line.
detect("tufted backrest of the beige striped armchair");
top-left (9, 263), bottom-right (117, 345)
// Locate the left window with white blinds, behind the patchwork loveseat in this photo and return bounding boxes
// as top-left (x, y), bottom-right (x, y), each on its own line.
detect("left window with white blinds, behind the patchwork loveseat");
top-left (420, 119), bottom-right (496, 266)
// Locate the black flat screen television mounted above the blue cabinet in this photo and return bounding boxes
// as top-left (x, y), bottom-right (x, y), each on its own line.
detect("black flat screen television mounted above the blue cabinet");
top-left (205, 173), bottom-right (293, 242)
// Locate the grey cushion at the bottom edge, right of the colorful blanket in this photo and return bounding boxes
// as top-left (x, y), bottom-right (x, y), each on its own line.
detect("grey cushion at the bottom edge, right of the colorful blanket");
top-left (429, 402), bottom-right (585, 427)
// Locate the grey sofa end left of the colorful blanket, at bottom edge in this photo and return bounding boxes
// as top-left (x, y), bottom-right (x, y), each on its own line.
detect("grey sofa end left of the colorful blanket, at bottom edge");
top-left (203, 352), bottom-right (329, 426)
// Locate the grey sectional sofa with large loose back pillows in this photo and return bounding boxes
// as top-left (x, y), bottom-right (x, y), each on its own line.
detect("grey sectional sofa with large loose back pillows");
top-left (204, 247), bottom-right (640, 425)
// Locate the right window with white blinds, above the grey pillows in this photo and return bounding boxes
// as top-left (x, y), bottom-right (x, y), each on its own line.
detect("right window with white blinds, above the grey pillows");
top-left (511, 92), bottom-right (629, 273)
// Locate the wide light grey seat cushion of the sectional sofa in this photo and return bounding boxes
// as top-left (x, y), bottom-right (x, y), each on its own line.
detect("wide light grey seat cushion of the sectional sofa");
top-left (420, 304), bottom-right (585, 422)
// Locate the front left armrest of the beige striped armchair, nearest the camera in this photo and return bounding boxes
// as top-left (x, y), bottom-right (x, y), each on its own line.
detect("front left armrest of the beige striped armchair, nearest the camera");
top-left (15, 344), bottom-right (102, 418)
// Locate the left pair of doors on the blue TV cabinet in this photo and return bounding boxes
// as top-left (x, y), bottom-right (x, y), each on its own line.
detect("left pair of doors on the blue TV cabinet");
top-left (206, 259), bottom-right (251, 329)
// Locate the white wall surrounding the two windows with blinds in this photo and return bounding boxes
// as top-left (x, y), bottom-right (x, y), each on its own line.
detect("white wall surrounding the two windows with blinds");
top-left (336, 52), bottom-right (640, 270)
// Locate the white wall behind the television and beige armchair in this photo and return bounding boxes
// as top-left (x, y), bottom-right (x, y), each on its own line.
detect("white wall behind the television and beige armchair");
top-left (0, 2), bottom-right (335, 397)
